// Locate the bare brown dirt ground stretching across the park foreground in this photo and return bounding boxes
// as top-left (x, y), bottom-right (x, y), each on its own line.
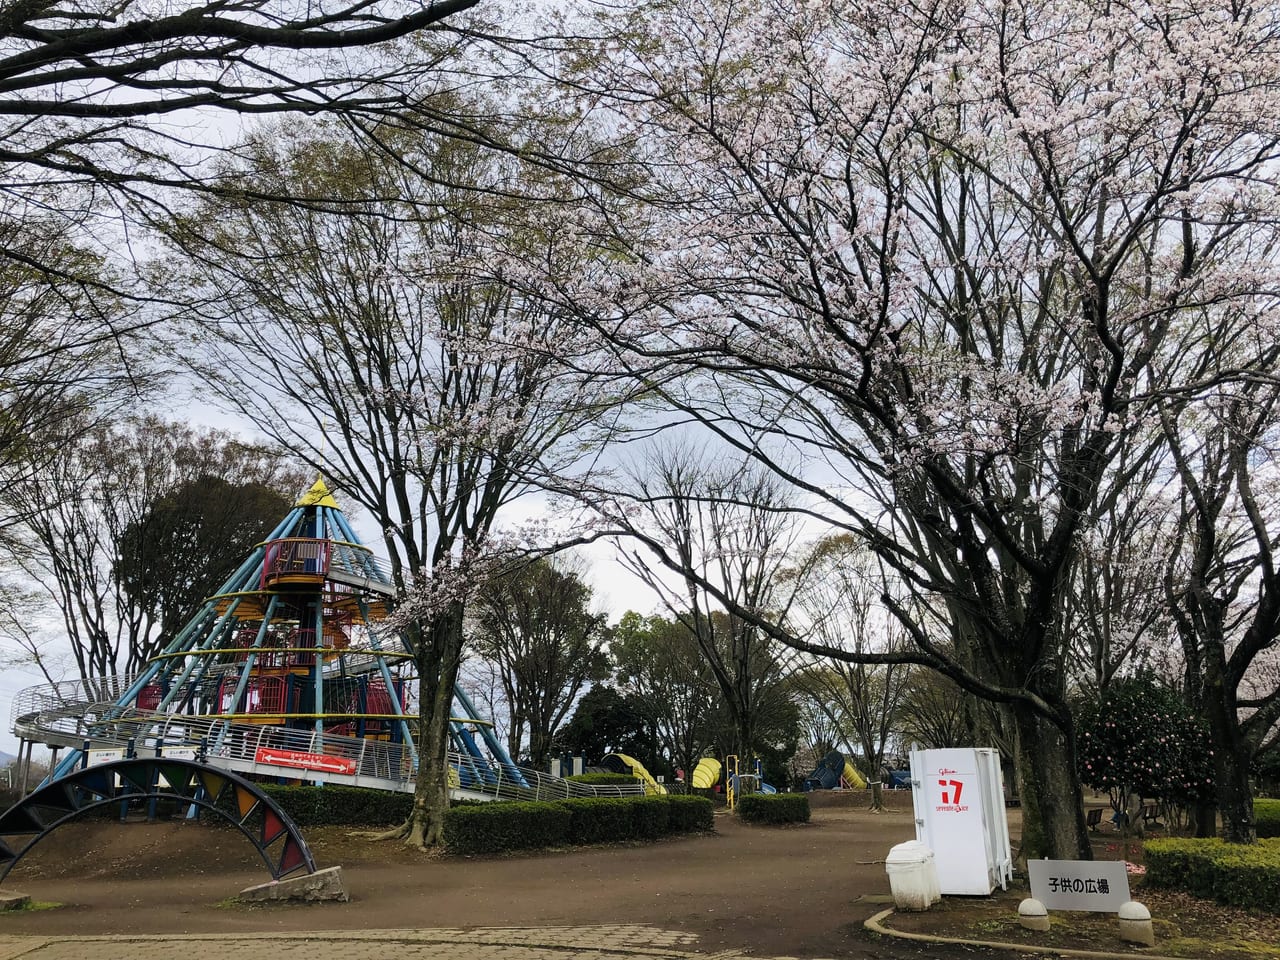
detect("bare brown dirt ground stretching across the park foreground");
top-left (0, 794), bottom-right (1280, 960)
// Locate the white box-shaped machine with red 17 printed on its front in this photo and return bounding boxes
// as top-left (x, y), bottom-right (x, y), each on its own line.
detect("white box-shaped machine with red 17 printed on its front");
top-left (911, 748), bottom-right (1014, 896)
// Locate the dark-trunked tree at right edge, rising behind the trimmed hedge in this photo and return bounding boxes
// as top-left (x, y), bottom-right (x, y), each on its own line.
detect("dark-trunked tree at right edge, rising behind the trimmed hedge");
top-left (1161, 376), bottom-right (1280, 844)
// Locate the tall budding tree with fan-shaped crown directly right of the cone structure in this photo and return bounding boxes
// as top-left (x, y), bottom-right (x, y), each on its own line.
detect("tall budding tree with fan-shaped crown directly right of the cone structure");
top-left (170, 120), bottom-right (605, 846)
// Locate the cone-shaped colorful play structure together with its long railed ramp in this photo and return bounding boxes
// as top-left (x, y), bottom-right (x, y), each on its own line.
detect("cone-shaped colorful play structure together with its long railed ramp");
top-left (13, 480), bottom-right (637, 800)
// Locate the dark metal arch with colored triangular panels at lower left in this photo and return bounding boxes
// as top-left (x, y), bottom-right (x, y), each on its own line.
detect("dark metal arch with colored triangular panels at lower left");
top-left (0, 756), bottom-right (316, 883)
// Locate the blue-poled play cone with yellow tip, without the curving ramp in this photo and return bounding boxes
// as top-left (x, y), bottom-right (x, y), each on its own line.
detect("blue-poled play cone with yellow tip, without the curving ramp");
top-left (45, 480), bottom-right (518, 786)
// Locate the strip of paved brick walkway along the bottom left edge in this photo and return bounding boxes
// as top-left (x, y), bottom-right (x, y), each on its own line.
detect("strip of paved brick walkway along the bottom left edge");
top-left (0, 924), bottom-right (795, 960)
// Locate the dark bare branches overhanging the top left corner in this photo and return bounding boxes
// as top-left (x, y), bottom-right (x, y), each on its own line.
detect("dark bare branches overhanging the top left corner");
top-left (0, 0), bottom-right (476, 205)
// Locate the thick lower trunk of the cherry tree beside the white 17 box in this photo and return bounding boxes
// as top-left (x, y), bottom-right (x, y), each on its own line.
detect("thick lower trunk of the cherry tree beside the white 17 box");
top-left (1011, 703), bottom-right (1093, 865)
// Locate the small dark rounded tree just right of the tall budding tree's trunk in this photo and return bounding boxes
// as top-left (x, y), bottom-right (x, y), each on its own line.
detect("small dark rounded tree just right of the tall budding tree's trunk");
top-left (470, 559), bottom-right (609, 768)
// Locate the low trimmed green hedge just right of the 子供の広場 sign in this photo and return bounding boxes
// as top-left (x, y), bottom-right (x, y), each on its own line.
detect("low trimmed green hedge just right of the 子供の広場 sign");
top-left (1144, 838), bottom-right (1280, 914)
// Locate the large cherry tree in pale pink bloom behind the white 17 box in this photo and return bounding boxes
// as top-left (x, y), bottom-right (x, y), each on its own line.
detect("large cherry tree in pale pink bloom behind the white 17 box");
top-left (545, 0), bottom-right (1280, 859)
